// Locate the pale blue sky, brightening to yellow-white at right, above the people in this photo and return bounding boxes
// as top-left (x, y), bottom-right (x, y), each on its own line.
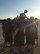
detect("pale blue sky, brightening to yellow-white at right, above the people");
top-left (0, 0), bottom-right (40, 19)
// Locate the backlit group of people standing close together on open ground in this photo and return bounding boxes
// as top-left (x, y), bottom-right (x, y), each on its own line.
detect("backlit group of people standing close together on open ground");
top-left (2, 10), bottom-right (38, 54)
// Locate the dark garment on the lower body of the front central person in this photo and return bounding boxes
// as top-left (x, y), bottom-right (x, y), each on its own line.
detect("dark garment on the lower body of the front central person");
top-left (14, 31), bottom-right (24, 46)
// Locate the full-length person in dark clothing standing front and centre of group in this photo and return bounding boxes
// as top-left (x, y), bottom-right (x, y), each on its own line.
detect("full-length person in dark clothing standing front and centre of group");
top-left (14, 19), bottom-right (24, 54)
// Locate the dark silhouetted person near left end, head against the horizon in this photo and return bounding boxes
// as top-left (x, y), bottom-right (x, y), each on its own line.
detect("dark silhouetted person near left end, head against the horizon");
top-left (6, 18), bottom-right (12, 44)
